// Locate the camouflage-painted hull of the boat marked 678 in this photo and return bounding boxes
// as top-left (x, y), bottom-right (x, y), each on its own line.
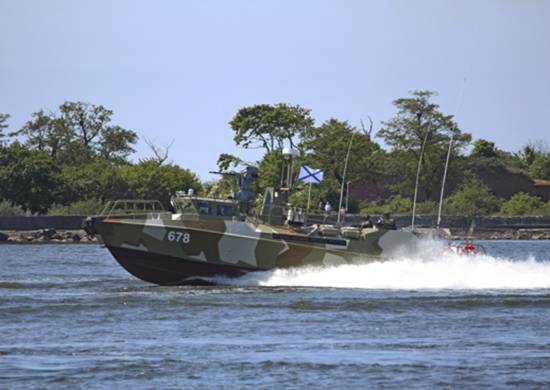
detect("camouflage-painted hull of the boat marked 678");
top-left (90, 218), bottom-right (416, 285)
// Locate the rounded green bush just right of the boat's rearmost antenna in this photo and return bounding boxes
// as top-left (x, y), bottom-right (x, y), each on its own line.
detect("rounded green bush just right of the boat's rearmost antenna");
top-left (445, 178), bottom-right (500, 217)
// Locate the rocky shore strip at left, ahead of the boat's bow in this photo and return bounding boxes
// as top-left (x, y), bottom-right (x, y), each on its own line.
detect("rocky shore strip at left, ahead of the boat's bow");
top-left (0, 229), bottom-right (98, 244)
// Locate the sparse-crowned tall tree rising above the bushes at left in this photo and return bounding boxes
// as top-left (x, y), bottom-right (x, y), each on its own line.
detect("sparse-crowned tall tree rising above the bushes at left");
top-left (15, 102), bottom-right (137, 165)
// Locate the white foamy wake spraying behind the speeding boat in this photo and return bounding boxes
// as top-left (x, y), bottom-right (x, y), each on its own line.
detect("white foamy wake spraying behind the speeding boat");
top-left (218, 241), bottom-right (550, 290)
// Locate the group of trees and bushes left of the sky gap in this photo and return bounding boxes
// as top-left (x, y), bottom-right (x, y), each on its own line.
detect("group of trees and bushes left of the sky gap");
top-left (0, 102), bottom-right (202, 215)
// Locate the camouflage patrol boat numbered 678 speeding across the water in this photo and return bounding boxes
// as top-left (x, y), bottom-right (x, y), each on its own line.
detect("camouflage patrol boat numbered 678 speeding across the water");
top-left (85, 154), bottom-right (417, 285)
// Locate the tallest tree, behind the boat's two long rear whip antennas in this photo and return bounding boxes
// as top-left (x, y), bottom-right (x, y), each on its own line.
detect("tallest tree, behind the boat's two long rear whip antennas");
top-left (377, 91), bottom-right (471, 200)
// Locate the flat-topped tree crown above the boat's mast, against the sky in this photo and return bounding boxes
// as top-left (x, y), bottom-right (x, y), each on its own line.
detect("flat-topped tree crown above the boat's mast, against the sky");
top-left (229, 103), bottom-right (314, 152)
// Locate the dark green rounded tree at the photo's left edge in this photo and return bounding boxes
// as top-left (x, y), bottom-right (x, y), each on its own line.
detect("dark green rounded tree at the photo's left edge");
top-left (0, 142), bottom-right (60, 213)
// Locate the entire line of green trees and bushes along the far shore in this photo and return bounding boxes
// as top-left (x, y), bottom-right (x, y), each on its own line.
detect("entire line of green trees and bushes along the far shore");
top-left (0, 91), bottom-right (550, 215)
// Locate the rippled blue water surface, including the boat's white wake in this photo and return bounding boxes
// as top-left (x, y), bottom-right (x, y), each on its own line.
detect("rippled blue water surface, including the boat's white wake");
top-left (0, 241), bottom-right (550, 388)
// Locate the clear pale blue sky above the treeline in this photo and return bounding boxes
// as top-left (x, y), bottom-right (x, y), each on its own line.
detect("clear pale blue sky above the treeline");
top-left (0, 0), bottom-right (550, 180)
